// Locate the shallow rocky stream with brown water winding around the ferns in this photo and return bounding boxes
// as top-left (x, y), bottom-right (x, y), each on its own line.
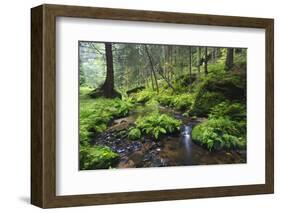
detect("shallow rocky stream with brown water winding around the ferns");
top-left (92, 106), bottom-right (246, 168)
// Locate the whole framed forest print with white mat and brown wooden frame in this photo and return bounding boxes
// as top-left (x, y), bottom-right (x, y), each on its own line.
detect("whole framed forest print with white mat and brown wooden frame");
top-left (31, 5), bottom-right (274, 208)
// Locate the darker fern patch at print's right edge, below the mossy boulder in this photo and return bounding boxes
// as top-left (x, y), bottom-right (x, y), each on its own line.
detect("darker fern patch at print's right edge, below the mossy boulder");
top-left (209, 101), bottom-right (246, 121)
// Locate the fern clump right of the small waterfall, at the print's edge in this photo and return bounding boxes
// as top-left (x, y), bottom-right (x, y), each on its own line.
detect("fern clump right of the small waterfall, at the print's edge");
top-left (192, 118), bottom-right (246, 151)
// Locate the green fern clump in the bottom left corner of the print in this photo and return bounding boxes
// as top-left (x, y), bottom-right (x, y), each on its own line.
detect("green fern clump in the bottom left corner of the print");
top-left (79, 146), bottom-right (119, 170)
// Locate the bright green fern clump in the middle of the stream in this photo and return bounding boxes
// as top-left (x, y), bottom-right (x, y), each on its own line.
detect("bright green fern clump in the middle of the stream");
top-left (135, 112), bottom-right (181, 139)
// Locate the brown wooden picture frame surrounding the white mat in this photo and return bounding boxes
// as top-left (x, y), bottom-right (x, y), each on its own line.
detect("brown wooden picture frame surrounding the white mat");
top-left (31, 5), bottom-right (274, 208)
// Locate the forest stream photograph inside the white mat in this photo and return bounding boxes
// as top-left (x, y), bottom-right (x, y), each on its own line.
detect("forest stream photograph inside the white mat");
top-left (78, 41), bottom-right (247, 170)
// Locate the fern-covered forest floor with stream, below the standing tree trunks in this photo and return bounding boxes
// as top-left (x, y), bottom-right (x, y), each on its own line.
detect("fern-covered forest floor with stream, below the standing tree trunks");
top-left (80, 69), bottom-right (247, 169)
